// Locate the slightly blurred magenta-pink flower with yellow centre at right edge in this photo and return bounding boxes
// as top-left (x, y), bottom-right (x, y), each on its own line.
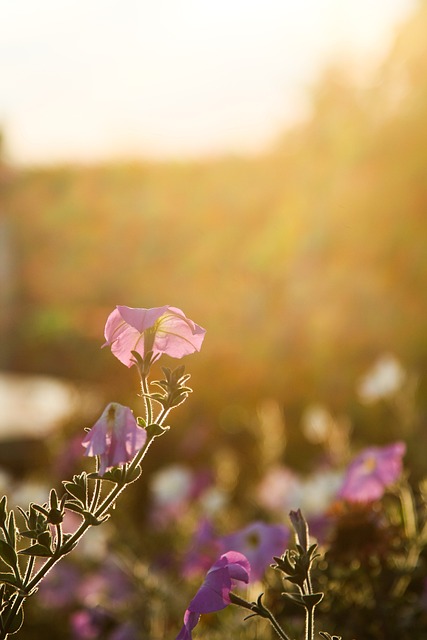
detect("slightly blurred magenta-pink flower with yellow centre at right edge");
top-left (338, 442), bottom-right (406, 502)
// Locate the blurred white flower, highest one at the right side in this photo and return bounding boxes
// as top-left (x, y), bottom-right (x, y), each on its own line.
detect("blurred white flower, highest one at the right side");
top-left (358, 355), bottom-right (406, 402)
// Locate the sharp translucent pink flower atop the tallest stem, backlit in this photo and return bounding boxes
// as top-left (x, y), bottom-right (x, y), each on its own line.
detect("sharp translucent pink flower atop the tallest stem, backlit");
top-left (103, 306), bottom-right (206, 367)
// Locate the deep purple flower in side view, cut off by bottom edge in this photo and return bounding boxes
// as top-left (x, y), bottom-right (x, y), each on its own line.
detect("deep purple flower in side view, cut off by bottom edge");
top-left (176, 551), bottom-right (251, 640)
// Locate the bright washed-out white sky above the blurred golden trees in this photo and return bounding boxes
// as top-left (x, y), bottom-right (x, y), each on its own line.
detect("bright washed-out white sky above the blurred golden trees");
top-left (0, 0), bottom-right (417, 164)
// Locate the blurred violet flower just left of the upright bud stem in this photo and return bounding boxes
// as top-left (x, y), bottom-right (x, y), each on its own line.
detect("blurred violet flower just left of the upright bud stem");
top-left (221, 522), bottom-right (289, 580)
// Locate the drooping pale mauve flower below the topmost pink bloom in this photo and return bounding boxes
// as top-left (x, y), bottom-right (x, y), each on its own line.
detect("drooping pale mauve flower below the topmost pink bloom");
top-left (82, 402), bottom-right (147, 476)
